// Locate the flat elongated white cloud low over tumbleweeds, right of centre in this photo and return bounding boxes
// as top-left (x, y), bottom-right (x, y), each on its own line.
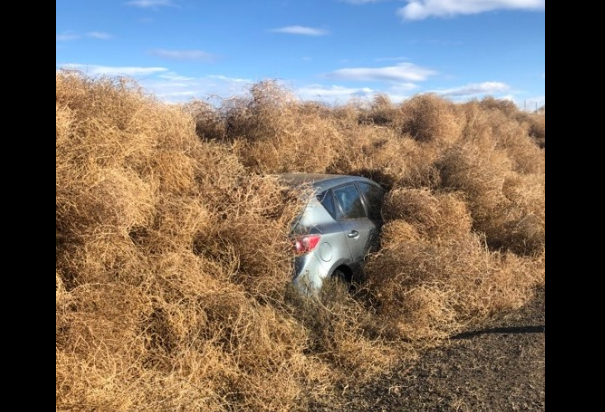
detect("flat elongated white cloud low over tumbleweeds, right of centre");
top-left (326, 63), bottom-right (437, 82)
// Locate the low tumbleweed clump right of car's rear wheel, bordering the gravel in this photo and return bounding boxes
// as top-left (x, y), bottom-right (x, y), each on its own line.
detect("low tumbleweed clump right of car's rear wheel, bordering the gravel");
top-left (366, 233), bottom-right (542, 341)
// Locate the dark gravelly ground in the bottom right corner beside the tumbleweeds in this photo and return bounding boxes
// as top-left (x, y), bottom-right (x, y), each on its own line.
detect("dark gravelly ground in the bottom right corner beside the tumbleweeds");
top-left (311, 288), bottom-right (546, 412)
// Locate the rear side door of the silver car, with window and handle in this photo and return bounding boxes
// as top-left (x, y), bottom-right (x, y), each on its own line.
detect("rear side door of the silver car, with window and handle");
top-left (332, 183), bottom-right (377, 270)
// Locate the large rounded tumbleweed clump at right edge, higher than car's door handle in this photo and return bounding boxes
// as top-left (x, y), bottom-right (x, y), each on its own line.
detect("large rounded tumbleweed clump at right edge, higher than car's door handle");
top-left (440, 138), bottom-right (546, 254)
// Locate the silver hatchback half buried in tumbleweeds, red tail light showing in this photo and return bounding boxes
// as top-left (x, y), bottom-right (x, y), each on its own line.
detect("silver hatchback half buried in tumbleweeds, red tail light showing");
top-left (279, 173), bottom-right (385, 294)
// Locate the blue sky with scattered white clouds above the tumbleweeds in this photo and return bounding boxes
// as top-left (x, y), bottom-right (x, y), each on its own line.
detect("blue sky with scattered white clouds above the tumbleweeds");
top-left (55, 0), bottom-right (546, 110)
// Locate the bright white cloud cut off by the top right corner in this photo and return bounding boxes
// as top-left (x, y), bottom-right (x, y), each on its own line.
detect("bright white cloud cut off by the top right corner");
top-left (397, 0), bottom-right (546, 20)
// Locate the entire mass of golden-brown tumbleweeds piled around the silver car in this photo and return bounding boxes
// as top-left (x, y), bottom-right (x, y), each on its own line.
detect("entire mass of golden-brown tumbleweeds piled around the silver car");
top-left (55, 73), bottom-right (545, 411)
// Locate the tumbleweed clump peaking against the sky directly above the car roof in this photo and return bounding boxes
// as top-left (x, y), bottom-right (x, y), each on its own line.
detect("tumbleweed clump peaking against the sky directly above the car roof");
top-left (218, 81), bottom-right (342, 173)
